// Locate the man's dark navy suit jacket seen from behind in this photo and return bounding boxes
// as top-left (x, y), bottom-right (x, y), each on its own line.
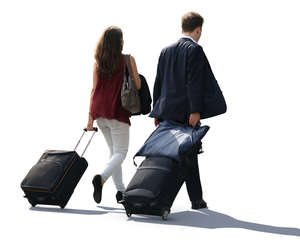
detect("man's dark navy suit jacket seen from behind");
top-left (149, 37), bottom-right (215, 123)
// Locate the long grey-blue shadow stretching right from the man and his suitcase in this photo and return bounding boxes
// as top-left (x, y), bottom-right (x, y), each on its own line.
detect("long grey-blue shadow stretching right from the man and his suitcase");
top-left (128, 209), bottom-right (300, 236)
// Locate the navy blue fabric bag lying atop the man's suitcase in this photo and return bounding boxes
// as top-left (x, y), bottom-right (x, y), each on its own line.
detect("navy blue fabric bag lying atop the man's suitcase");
top-left (133, 120), bottom-right (209, 162)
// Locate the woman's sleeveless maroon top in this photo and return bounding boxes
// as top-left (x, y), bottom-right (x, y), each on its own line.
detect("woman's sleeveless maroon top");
top-left (91, 63), bottom-right (130, 125)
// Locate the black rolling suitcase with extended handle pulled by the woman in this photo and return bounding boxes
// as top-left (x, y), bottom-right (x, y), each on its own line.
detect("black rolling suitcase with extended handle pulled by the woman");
top-left (21, 128), bottom-right (98, 208)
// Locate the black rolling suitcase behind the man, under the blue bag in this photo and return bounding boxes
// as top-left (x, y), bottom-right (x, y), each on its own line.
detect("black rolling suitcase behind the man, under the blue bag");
top-left (121, 157), bottom-right (184, 220)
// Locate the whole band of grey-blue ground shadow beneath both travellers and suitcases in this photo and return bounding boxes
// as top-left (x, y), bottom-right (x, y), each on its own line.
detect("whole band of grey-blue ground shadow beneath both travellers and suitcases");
top-left (30, 206), bottom-right (300, 237)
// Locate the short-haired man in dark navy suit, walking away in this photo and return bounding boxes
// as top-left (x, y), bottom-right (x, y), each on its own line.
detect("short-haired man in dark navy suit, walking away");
top-left (150, 12), bottom-right (207, 209)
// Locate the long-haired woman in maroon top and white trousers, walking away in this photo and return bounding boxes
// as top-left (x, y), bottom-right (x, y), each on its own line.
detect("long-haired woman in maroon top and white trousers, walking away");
top-left (87, 26), bottom-right (141, 203)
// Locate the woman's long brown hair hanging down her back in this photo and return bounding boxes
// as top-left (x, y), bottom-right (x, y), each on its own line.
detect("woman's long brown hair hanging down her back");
top-left (95, 26), bottom-right (123, 79)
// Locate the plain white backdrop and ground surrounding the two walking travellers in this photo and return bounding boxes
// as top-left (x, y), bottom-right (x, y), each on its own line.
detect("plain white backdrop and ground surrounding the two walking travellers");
top-left (0, 0), bottom-right (300, 239)
